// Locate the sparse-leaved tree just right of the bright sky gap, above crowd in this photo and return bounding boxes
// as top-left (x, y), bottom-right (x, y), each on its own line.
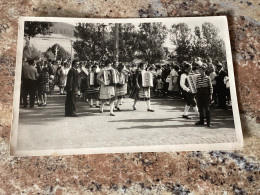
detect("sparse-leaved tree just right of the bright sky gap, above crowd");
top-left (170, 23), bottom-right (192, 63)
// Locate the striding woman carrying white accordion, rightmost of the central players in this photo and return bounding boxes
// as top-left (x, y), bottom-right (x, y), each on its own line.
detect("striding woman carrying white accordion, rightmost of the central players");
top-left (129, 62), bottom-right (154, 112)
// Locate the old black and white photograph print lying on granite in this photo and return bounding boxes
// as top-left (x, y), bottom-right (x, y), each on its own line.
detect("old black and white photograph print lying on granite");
top-left (10, 16), bottom-right (243, 156)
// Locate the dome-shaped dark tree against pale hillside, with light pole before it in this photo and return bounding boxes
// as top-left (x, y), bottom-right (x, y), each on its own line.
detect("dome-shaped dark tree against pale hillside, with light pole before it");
top-left (45, 43), bottom-right (71, 60)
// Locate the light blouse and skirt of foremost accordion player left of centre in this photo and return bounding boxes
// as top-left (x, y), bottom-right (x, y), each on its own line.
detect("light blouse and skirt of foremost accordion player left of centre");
top-left (98, 68), bottom-right (116, 101)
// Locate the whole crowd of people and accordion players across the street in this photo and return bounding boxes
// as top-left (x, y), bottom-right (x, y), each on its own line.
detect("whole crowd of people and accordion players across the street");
top-left (20, 58), bottom-right (231, 127)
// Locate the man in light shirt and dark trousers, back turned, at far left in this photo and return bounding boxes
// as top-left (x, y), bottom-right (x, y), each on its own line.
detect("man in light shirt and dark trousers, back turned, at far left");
top-left (22, 59), bottom-right (38, 108)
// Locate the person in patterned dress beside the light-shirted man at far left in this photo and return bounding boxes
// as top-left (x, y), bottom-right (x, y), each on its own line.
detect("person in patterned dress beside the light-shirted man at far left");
top-left (38, 67), bottom-right (50, 106)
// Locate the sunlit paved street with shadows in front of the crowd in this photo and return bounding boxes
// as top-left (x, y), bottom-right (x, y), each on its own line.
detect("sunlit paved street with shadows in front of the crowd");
top-left (17, 89), bottom-right (236, 150)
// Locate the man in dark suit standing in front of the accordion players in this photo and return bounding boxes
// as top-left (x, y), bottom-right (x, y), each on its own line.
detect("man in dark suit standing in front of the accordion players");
top-left (65, 60), bottom-right (80, 117)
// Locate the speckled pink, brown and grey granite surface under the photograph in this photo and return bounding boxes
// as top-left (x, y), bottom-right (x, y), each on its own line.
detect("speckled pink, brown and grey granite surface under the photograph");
top-left (0, 0), bottom-right (260, 194)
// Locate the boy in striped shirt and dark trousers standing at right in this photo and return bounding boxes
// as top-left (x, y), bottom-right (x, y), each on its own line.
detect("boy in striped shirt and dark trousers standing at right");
top-left (195, 64), bottom-right (213, 127)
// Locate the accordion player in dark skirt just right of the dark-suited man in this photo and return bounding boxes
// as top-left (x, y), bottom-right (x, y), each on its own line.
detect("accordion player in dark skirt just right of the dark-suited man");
top-left (87, 64), bottom-right (100, 108)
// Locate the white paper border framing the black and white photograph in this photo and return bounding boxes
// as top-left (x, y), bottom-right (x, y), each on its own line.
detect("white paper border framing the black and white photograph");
top-left (10, 16), bottom-right (243, 156)
